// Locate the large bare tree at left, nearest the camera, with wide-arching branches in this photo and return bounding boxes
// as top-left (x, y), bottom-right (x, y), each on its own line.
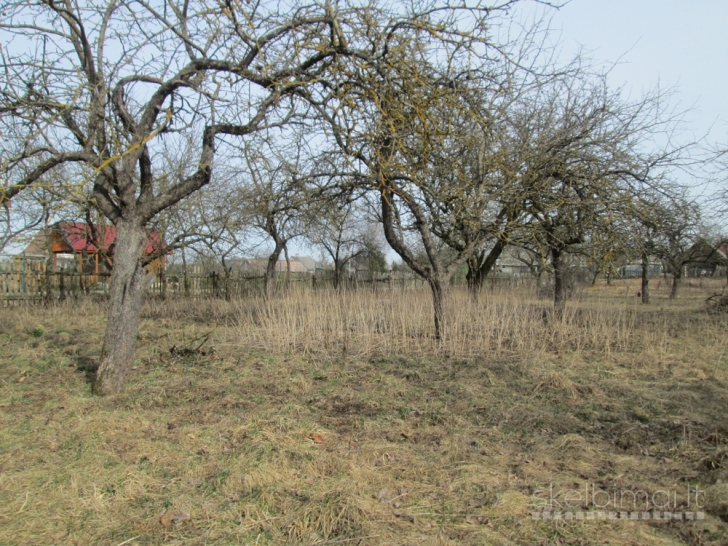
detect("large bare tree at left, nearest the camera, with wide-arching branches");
top-left (0, 0), bottom-right (392, 394)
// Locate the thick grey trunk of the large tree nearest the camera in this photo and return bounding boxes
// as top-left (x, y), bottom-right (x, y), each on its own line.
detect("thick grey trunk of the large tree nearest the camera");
top-left (93, 220), bottom-right (147, 395)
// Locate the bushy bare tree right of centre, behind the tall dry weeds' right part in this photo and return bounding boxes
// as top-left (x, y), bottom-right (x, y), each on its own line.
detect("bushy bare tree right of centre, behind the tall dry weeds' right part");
top-left (504, 67), bottom-right (686, 318)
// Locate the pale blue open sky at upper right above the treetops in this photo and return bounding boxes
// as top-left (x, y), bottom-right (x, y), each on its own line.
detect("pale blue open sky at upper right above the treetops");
top-left (518, 0), bottom-right (728, 151)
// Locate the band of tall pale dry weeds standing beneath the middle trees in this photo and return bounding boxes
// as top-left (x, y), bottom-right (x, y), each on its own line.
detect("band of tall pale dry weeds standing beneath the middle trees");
top-left (164, 284), bottom-right (720, 358)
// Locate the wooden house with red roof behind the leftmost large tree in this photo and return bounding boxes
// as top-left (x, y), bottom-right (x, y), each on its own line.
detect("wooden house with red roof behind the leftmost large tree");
top-left (23, 222), bottom-right (166, 275)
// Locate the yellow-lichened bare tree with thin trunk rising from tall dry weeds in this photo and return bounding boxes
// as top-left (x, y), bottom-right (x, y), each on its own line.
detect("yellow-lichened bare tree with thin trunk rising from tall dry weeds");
top-left (312, 21), bottom-right (528, 339)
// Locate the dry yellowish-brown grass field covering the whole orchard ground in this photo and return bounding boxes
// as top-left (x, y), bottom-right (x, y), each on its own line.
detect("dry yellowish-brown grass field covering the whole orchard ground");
top-left (0, 281), bottom-right (728, 545)
